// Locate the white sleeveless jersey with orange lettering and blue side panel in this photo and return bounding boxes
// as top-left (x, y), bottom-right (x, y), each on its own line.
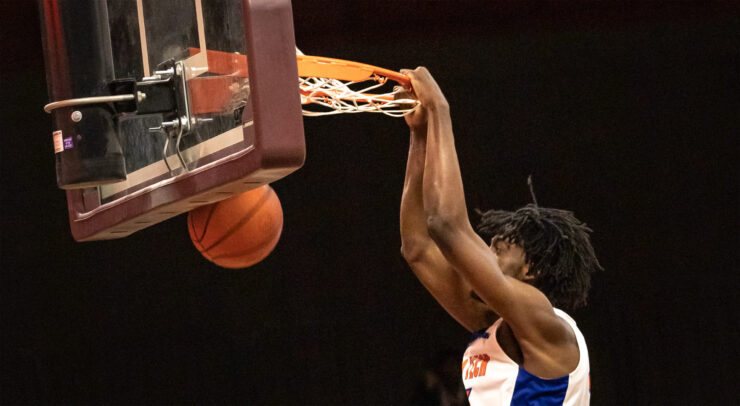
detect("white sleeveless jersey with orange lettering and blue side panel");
top-left (462, 309), bottom-right (591, 406)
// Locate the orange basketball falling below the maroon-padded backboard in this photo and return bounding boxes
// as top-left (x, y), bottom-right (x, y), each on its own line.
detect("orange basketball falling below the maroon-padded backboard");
top-left (188, 185), bottom-right (283, 269)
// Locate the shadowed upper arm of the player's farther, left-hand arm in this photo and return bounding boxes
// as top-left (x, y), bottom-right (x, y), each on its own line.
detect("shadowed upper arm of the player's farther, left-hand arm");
top-left (409, 243), bottom-right (497, 331)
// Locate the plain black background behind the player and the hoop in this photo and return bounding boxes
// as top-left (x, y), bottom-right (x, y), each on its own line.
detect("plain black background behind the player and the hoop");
top-left (0, 0), bottom-right (740, 405)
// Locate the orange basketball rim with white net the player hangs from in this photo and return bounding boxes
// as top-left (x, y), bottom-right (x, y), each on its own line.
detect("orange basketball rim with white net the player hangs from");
top-left (296, 55), bottom-right (420, 117)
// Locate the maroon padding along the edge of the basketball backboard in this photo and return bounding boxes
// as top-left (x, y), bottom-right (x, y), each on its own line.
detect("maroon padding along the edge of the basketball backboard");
top-left (62, 0), bottom-right (306, 241)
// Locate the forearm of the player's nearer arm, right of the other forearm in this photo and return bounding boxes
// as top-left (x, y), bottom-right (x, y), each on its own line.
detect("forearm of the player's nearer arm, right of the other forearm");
top-left (423, 103), bottom-right (468, 232)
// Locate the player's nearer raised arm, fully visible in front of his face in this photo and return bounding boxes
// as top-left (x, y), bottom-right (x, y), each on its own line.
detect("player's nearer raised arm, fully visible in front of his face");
top-left (408, 68), bottom-right (560, 342)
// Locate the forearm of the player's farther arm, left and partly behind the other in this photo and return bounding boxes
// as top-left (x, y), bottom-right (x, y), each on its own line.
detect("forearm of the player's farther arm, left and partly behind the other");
top-left (401, 127), bottom-right (431, 259)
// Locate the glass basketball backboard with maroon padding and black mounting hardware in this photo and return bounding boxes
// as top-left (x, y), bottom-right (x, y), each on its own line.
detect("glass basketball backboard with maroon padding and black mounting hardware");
top-left (40, 0), bottom-right (305, 241)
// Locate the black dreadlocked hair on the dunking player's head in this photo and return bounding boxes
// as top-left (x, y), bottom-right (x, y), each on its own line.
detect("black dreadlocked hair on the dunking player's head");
top-left (477, 204), bottom-right (603, 310)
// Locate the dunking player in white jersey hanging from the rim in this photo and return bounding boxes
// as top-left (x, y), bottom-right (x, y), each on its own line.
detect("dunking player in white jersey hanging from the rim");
top-left (401, 67), bottom-right (601, 405)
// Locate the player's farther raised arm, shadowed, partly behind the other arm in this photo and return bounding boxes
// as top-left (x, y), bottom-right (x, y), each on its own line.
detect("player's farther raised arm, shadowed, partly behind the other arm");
top-left (401, 85), bottom-right (496, 331)
